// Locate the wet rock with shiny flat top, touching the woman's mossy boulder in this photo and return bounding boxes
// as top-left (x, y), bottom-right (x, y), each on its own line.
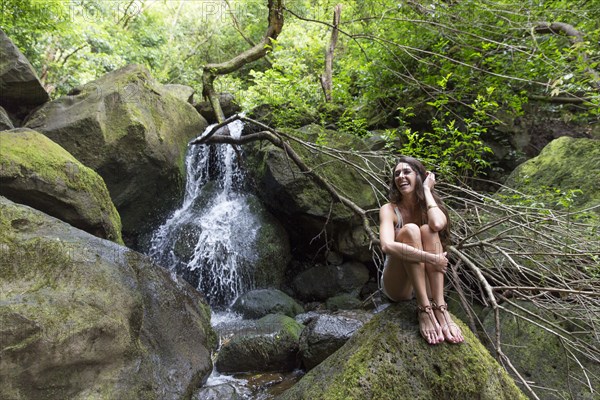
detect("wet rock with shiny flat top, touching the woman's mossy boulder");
top-left (300, 312), bottom-right (371, 370)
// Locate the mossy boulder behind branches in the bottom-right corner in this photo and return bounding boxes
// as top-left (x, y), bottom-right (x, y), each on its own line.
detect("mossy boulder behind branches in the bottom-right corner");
top-left (483, 301), bottom-right (600, 400)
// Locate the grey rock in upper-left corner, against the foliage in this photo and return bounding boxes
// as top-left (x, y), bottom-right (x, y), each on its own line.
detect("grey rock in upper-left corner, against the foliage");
top-left (0, 29), bottom-right (50, 118)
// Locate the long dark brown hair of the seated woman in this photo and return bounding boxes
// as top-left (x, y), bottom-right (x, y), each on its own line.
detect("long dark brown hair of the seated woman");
top-left (389, 156), bottom-right (450, 248)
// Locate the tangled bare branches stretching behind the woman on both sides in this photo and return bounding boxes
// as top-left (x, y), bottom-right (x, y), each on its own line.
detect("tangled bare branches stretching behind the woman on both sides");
top-left (192, 115), bottom-right (600, 398)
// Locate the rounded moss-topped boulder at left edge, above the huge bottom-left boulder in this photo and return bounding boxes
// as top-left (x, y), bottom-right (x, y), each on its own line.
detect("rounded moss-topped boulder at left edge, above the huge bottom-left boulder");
top-left (0, 129), bottom-right (123, 243)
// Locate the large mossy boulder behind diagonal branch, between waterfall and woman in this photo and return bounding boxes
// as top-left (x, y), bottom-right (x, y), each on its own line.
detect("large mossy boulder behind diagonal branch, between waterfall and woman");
top-left (246, 125), bottom-right (377, 258)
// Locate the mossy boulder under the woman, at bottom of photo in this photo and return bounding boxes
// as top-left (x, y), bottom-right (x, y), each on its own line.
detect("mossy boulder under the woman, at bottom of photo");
top-left (277, 302), bottom-right (526, 400)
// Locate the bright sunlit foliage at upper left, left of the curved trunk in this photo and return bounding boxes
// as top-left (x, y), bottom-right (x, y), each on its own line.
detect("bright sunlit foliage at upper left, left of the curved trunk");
top-left (0, 0), bottom-right (251, 97)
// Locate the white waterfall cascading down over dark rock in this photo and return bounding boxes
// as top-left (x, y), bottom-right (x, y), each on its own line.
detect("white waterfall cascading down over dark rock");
top-left (149, 121), bottom-right (259, 309)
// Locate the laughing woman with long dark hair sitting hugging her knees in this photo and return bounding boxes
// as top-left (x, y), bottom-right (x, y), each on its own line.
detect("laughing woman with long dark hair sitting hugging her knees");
top-left (379, 157), bottom-right (464, 344)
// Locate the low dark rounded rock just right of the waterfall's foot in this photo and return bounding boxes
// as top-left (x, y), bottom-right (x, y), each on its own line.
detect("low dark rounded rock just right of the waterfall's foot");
top-left (231, 289), bottom-right (304, 319)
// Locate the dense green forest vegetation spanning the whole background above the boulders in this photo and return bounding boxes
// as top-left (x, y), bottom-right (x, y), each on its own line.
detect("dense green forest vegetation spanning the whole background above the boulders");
top-left (0, 0), bottom-right (600, 175)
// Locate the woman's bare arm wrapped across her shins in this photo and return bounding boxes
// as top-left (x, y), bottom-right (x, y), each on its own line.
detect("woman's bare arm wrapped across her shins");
top-left (379, 203), bottom-right (448, 267)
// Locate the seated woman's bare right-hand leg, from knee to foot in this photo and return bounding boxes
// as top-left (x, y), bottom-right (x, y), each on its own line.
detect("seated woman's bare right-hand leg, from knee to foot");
top-left (421, 225), bottom-right (464, 343)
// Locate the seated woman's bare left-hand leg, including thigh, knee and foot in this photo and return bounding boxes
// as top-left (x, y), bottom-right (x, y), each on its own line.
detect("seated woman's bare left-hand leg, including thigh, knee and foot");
top-left (382, 224), bottom-right (444, 344)
